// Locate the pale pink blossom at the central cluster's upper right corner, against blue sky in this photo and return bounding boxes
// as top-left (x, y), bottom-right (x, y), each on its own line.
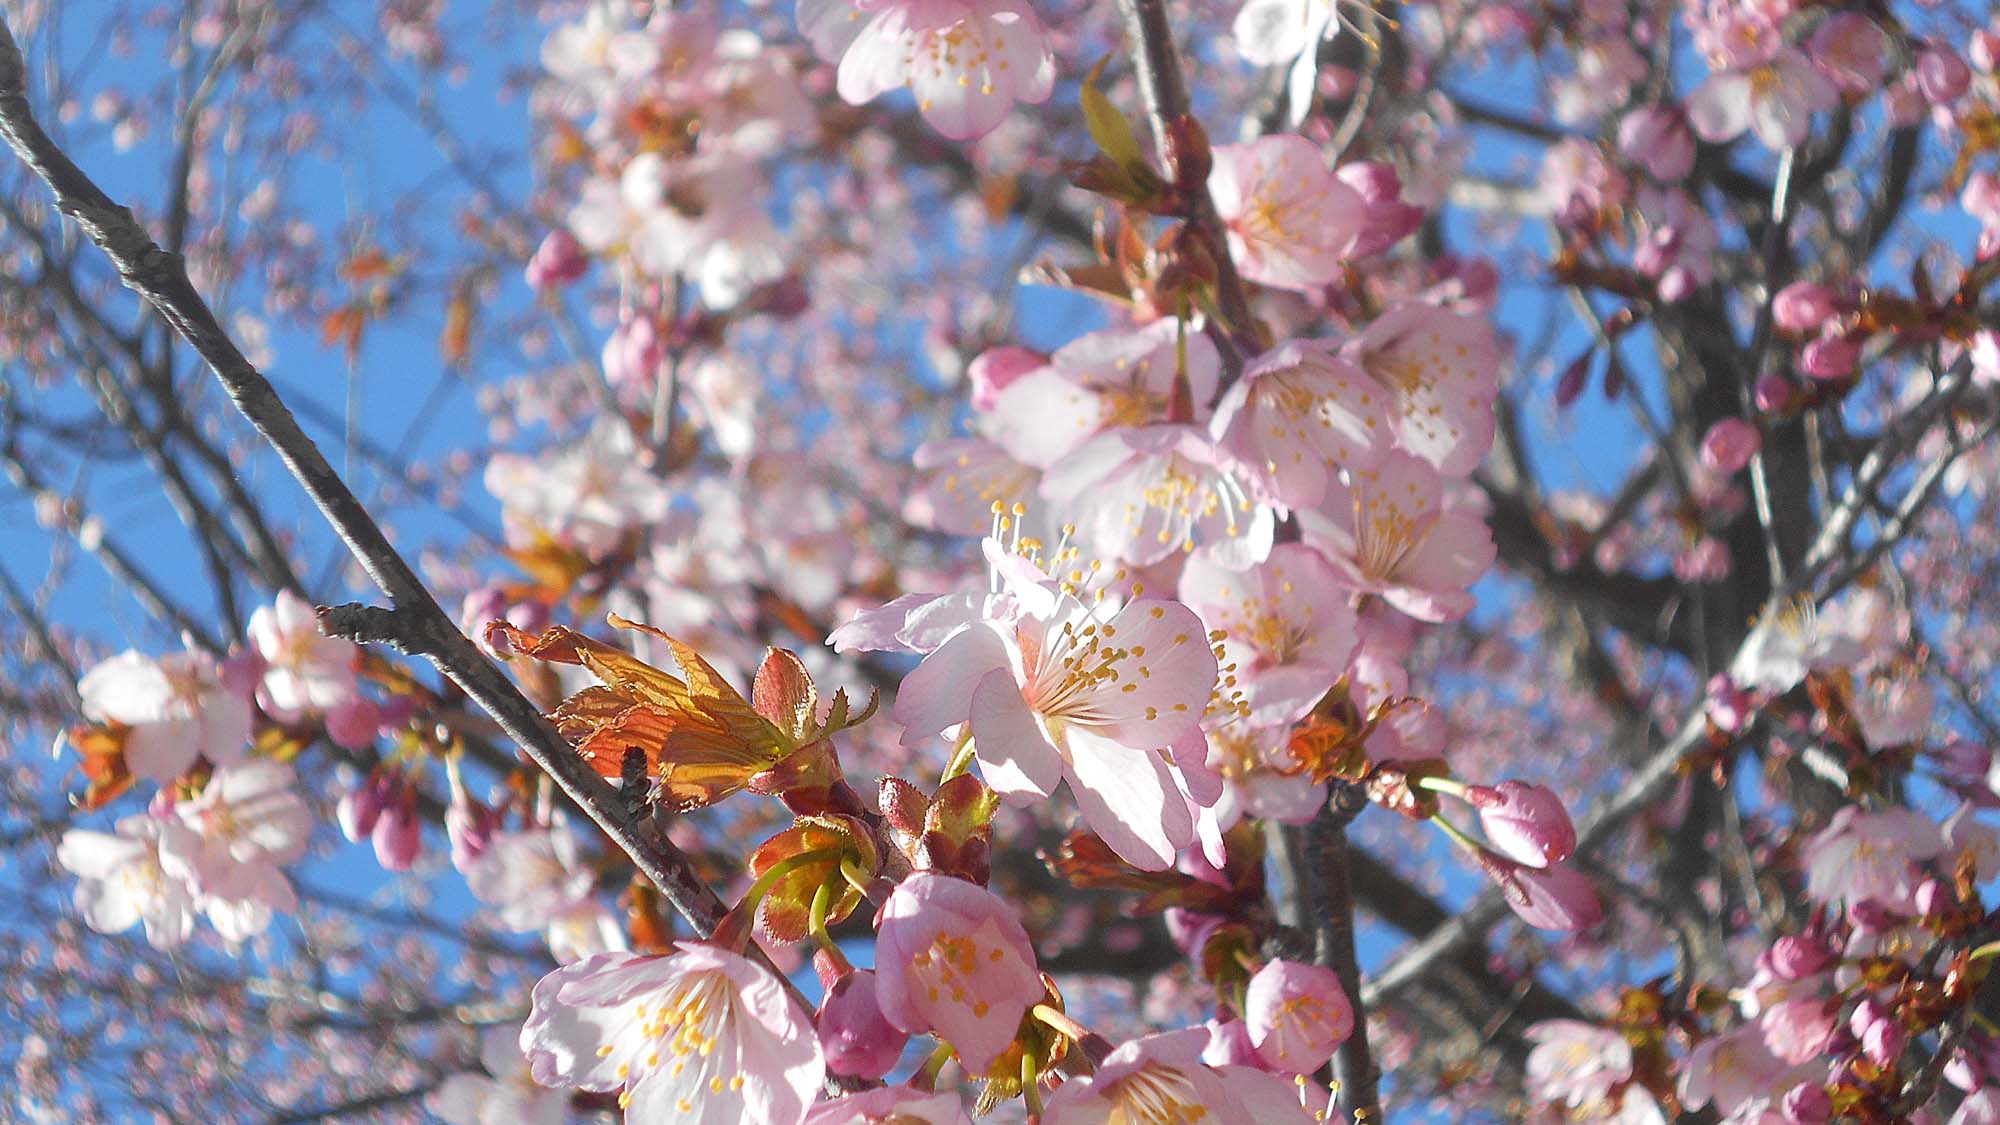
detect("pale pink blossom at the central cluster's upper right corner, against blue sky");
top-left (1340, 302), bottom-right (1500, 476)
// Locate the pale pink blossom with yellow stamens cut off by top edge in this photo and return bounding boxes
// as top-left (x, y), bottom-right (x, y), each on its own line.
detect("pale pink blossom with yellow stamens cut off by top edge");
top-left (798, 0), bottom-right (1056, 140)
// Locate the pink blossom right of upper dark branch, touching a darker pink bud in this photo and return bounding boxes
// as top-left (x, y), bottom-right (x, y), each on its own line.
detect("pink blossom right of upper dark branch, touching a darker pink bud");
top-left (1208, 134), bottom-right (1368, 292)
